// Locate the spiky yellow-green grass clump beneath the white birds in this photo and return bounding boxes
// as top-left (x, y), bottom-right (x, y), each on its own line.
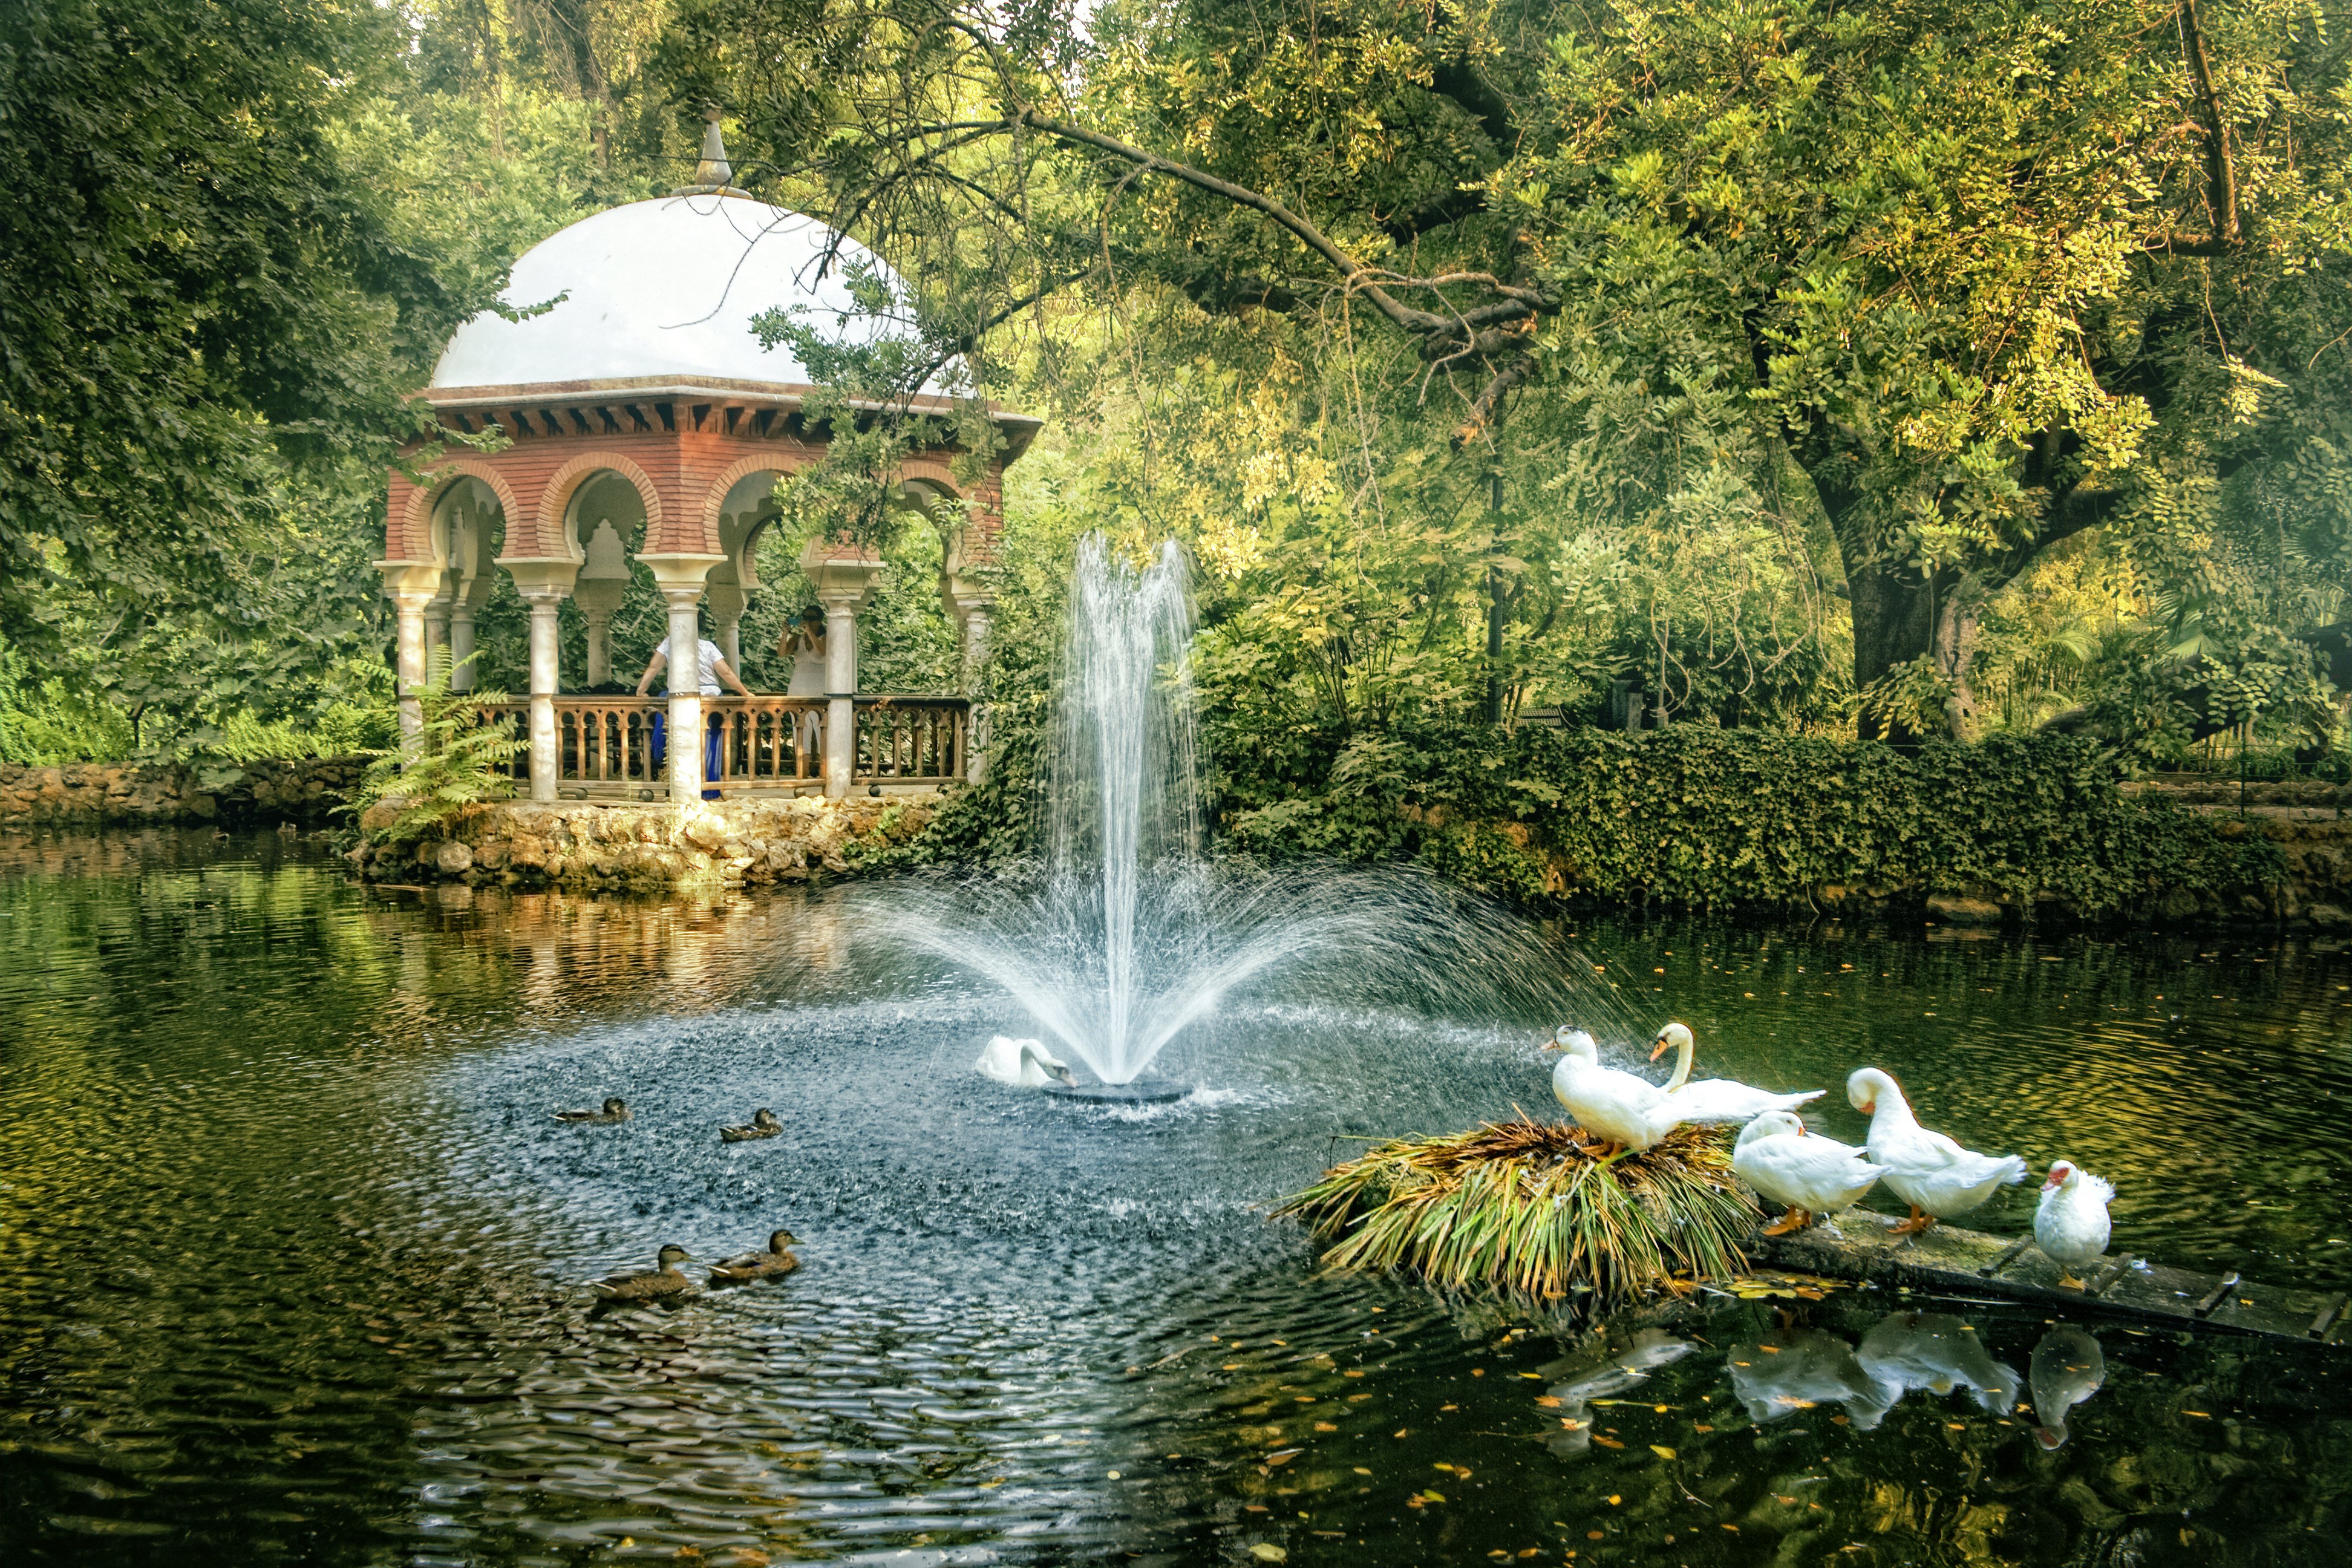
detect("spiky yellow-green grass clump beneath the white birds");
top-left (1275, 1112), bottom-right (1759, 1307)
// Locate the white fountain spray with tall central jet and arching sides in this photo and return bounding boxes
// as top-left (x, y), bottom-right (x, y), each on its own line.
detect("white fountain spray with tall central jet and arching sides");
top-left (872, 534), bottom-right (1630, 1103)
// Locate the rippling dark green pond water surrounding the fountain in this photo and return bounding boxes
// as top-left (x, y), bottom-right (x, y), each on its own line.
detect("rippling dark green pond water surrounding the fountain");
top-left (0, 835), bottom-right (2352, 1566)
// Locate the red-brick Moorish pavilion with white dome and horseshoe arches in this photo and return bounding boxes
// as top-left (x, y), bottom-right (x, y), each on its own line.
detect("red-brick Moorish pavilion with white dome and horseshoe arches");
top-left (379, 122), bottom-right (1039, 802)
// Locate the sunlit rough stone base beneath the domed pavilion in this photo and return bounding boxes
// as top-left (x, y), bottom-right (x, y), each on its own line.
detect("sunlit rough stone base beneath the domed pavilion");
top-left (350, 792), bottom-right (938, 891)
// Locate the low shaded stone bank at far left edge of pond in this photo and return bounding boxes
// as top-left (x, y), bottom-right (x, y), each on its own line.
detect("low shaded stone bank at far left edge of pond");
top-left (0, 757), bottom-right (367, 828)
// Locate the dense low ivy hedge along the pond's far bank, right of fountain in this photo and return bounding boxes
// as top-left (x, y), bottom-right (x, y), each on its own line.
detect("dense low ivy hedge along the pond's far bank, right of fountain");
top-left (1218, 727), bottom-right (2279, 917)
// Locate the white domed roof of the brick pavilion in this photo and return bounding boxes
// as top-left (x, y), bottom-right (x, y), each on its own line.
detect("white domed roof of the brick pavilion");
top-left (433, 193), bottom-right (938, 393)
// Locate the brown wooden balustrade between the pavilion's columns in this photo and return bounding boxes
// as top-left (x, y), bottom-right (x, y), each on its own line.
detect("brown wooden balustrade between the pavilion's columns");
top-left (482, 696), bottom-right (972, 790)
